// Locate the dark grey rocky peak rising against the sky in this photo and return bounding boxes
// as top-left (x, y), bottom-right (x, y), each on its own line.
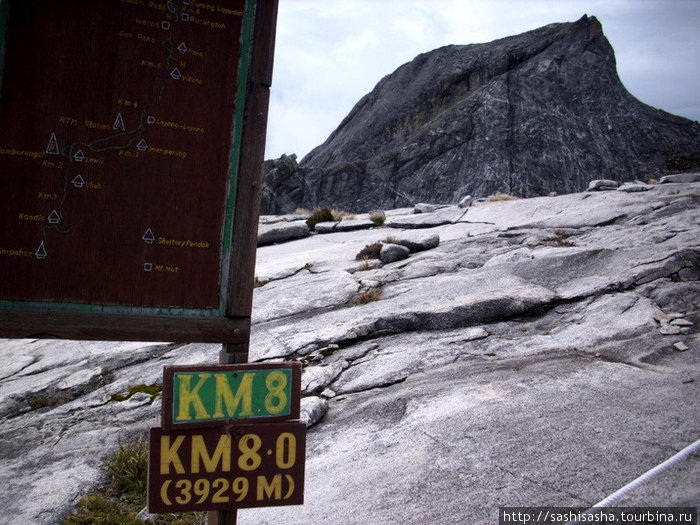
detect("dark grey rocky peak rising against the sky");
top-left (263, 16), bottom-right (700, 213)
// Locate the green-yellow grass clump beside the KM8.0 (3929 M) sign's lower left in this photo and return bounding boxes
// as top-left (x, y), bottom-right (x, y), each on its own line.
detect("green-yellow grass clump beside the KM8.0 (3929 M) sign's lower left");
top-left (63, 436), bottom-right (205, 525)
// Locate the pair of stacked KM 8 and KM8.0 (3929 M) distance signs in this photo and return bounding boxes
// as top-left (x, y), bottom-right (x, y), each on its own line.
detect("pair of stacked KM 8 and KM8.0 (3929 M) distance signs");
top-left (148, 363), bottom-right (306, 523)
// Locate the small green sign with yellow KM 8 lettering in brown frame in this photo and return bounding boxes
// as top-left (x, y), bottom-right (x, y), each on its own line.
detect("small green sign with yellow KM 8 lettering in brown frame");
top-left (161, 363), bottom-right (301, 429)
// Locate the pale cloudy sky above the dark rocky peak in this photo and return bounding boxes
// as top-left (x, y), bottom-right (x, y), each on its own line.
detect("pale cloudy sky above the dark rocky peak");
top-left (265, 0), bottom-right (700, 160)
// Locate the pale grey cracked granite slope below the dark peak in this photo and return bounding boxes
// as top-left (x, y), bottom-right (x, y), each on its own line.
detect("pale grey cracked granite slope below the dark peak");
top-left (0, 178), bottom-right (700, 525)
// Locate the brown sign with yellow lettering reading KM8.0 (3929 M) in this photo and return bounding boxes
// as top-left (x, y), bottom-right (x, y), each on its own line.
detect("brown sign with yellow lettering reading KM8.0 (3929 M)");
top-left (147, 422), bottom-right (306, 513)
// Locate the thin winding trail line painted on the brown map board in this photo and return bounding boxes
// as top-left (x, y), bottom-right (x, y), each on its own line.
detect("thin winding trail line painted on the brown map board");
top-left (35, 1), bottom-right (186, 259)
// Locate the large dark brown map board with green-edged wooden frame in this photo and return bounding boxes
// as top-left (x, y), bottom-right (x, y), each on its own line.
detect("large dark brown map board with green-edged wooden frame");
top-left (0, 0), bottom-right (276, 343)
